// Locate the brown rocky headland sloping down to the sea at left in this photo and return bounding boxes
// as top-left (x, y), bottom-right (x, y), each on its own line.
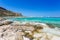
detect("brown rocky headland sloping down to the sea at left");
top-left (0, 7), bottom-right (23, 16)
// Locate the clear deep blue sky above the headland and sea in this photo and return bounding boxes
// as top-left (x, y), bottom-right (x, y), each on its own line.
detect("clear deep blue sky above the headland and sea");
top-left (0, 0), bottom-right (60, 17)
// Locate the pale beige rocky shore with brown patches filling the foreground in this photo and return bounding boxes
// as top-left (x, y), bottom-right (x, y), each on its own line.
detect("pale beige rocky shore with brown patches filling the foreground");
top-left (0, 17), bottom-right (60, 40)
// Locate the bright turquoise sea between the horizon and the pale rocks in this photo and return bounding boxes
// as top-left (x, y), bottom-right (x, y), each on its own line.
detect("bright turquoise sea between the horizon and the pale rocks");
top-left (8, 17), bottom-right (60, 27)
